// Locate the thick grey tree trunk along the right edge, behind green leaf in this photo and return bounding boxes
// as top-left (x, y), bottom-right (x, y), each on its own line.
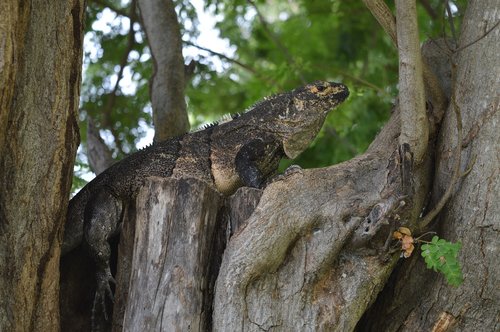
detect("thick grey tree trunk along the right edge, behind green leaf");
top-left (360, 0), bottom-right (500, 331)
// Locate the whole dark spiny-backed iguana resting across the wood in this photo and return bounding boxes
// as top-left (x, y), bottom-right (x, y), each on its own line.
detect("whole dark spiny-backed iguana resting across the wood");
top-left (62, 81), bottom-right (349, 320)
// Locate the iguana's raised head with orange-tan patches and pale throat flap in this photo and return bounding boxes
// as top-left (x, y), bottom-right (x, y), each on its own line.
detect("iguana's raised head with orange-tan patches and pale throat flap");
top-left (268, 81), bottom-right (349, 159)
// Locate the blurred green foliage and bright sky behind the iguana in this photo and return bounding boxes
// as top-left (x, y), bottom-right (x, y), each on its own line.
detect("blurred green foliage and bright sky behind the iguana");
top-left (74, 0), bottom-right (465, 191)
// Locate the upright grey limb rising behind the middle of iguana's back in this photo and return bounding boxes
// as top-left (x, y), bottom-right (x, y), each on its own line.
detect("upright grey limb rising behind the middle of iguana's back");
top-left (138, 0), bottom-right (189, 141)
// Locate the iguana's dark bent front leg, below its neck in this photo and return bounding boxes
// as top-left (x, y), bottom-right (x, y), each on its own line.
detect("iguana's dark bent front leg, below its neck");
top-left (234, 138), bottom-right (284, 188)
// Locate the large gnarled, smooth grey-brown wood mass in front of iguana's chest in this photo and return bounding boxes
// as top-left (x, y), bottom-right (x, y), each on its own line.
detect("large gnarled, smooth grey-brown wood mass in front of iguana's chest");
top-left (214, 105), bottom-right (436, 331)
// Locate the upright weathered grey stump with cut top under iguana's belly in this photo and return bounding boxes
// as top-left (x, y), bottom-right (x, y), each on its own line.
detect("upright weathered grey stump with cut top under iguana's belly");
top-left (113, 178), bottom-right (261, 331)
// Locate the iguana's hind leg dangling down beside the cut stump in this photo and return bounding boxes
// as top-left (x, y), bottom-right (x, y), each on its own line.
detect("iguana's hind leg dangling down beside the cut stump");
top-left (84, 189), bottom-right (123, 325)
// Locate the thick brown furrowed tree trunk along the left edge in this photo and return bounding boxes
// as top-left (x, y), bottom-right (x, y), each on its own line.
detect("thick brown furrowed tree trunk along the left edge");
top-left (0, 0), bottom-right (84, 331)
